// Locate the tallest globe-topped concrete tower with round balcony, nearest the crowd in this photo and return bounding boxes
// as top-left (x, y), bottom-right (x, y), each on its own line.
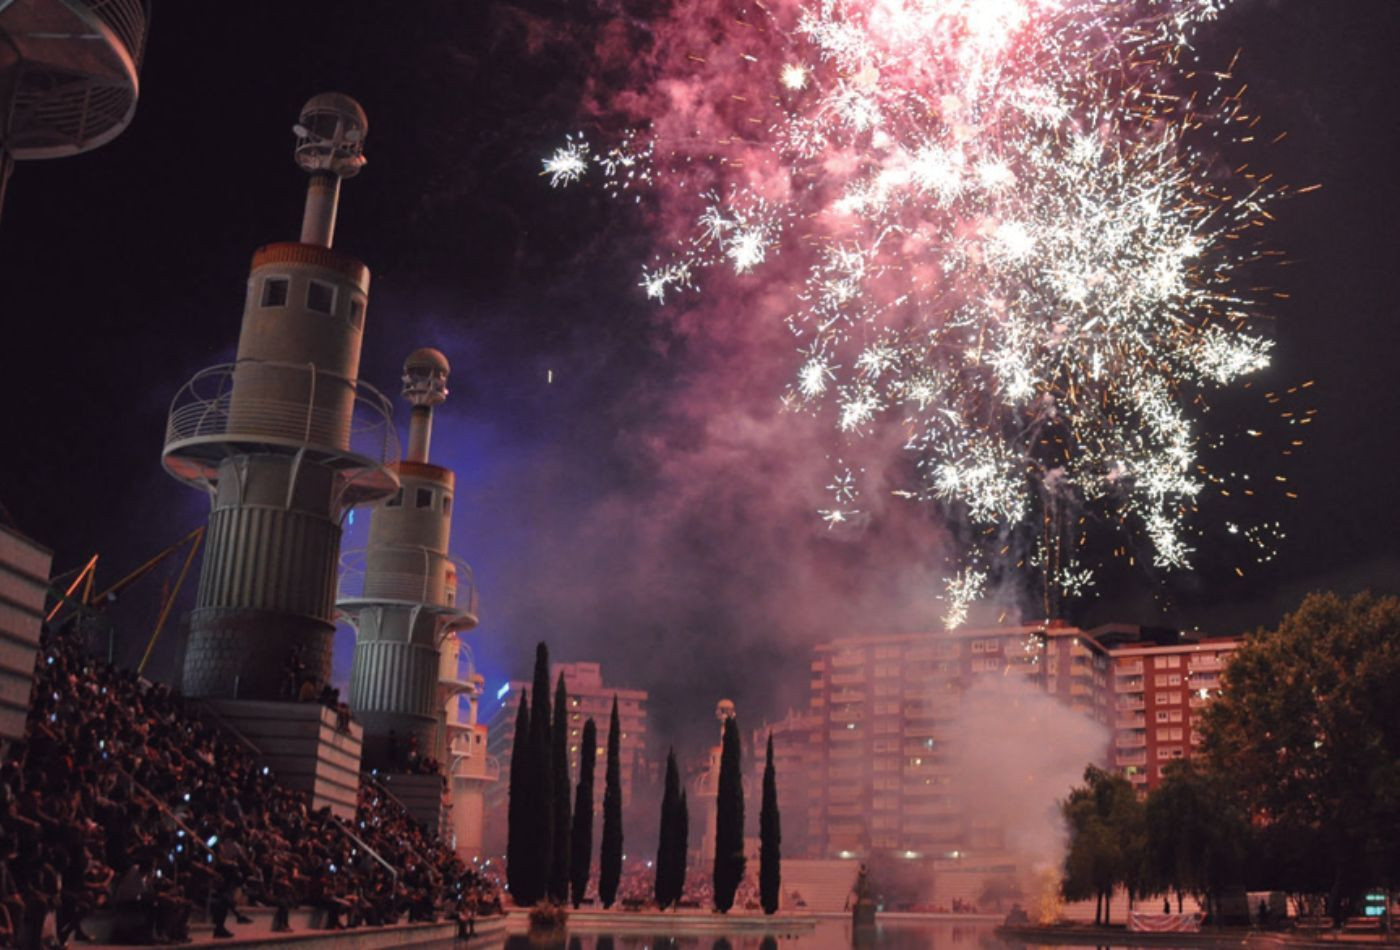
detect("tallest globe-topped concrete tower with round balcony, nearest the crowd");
top-left (162, 92), bottom-right (399, 817)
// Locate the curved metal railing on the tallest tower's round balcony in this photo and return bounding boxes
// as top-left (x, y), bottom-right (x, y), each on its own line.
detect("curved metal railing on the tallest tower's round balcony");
top-left (165, 360), bottom-right (399, 466)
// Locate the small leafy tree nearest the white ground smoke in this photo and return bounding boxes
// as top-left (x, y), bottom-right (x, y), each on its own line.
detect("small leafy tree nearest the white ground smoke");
top-left (1061, 765), bottom-right (1147, 925)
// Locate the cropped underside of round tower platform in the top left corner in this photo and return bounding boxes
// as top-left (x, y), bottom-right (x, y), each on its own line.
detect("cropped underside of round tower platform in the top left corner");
top-left (0, 0), bottom-right (148, 222)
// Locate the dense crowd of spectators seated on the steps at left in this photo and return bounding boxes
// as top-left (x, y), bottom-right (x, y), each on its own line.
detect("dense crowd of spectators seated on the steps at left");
top-left (0, 631), bottom-right (500, 947)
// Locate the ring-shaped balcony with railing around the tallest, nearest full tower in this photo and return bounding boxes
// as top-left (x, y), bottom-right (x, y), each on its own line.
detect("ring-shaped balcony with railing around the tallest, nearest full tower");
top-left (161, 360), bottom-right (399, 508)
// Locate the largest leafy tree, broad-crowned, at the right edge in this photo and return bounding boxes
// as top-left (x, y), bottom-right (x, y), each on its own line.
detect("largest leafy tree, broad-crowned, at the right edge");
top-left (1204, 593), bottom-right (1400, 922)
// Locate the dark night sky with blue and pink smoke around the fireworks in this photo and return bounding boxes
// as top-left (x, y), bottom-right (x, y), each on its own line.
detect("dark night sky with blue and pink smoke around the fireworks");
top-left (0, 0), bottom-right (1400, 735)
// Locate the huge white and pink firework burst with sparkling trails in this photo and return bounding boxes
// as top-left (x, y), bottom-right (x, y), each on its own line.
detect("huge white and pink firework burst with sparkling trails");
top-left (545, 0), bottom-right (1281, 625)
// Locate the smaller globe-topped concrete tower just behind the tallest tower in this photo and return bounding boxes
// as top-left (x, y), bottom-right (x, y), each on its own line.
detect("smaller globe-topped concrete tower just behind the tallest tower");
top-left (337, 348), bottom-right (476, 777)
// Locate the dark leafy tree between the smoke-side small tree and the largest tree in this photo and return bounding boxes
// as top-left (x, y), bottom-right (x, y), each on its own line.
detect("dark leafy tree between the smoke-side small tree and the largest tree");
top-left (1145, 758), bottom-right (1249, 919)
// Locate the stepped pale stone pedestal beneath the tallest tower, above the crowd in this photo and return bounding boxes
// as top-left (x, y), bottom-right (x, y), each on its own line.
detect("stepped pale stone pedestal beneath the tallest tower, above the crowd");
top-left (204, 700), bottom-right (364, 821)
